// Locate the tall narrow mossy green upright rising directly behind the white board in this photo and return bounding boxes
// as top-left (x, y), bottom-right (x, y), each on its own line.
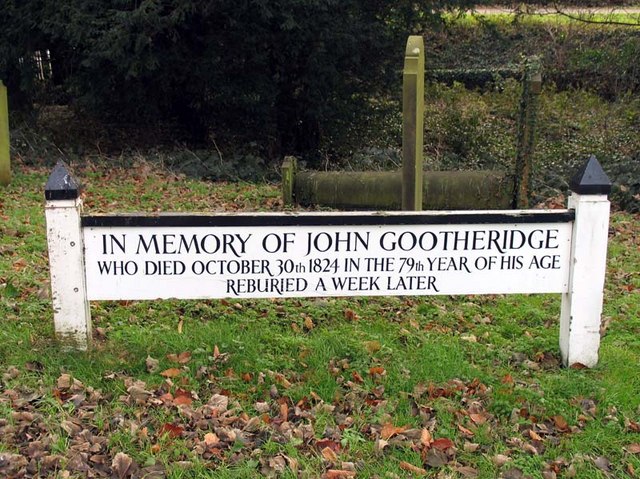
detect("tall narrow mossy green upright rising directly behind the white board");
top-left (402, 35), bottom-right (424, 211)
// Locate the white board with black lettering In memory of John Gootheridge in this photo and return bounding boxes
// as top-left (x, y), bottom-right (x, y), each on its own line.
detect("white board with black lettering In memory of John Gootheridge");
top-left (83, 212), bottom-right (572, 300)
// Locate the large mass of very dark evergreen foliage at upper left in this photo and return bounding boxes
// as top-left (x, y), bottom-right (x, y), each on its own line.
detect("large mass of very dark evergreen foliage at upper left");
top-left (0, 0), bottom-right (484, 163)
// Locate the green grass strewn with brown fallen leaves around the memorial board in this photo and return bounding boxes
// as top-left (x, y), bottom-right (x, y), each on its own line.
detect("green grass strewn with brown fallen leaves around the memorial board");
top-left (0, 164), bottom-right (640, 478)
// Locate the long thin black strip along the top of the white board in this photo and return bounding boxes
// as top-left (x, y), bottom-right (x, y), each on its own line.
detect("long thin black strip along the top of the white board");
top-left (82, 210), bottom-right (575, 228)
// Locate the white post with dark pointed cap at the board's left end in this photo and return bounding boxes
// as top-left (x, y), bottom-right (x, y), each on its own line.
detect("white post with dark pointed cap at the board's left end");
top-left (45, 161), bottom-right (91, 350)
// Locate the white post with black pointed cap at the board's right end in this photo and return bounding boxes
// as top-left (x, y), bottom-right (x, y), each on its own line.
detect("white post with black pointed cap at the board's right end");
top-left (560, 156), bottom-right (611, 367)
